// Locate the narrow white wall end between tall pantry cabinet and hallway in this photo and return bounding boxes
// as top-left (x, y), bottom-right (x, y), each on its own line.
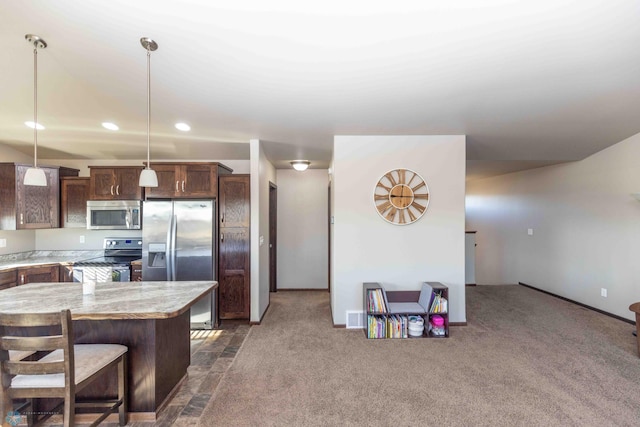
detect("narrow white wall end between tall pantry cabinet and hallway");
top-left (249, 139), bottom-right (277, 322)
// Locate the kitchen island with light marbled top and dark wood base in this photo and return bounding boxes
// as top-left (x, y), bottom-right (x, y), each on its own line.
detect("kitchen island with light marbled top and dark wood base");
top-left (0, 281), bottom-right (218, 422)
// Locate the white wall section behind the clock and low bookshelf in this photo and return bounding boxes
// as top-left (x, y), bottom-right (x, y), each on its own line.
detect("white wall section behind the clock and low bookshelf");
top-left (331, 135), bottom-right (466, 324)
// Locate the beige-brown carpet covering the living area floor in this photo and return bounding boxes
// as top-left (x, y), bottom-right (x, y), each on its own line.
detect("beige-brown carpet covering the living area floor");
top-left (199, 285), bottom-right (640, 426)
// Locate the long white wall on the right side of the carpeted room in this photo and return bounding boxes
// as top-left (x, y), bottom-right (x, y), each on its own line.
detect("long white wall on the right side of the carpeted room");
top-left (467, 134), bottom-right (640, 320)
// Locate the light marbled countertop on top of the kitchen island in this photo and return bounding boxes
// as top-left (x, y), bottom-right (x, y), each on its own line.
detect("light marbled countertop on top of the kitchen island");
top-left (0, 281), bottom-right (218, 320)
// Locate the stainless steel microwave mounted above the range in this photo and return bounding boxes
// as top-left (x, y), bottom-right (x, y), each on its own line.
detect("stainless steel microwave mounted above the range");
top-left (87, 200), bottom-right (142, 230)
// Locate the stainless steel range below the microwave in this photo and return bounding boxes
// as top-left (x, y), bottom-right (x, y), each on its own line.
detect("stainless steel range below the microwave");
top-left (73, 237), bottom-right (142, 282)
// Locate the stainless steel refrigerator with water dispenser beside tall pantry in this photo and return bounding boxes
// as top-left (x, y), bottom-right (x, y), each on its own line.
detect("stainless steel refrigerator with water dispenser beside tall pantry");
top-left (142, 200), bottom-right (217, 329)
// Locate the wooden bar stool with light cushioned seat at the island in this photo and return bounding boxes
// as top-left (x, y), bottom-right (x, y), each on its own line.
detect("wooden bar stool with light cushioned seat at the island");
top-left (0, 310), bottom-right (127, 427)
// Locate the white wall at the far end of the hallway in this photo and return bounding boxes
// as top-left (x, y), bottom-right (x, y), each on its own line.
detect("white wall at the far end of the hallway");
top-left (277, 169), bottom-right (329, 289)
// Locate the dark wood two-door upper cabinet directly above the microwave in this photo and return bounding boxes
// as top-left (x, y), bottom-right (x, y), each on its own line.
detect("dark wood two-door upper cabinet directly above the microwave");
top-left (89, 166), bottom-right (144, 200)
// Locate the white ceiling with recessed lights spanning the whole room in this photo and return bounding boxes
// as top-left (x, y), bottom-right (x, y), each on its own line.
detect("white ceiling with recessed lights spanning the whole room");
top-left (0, 0), bottom-right (640, 177)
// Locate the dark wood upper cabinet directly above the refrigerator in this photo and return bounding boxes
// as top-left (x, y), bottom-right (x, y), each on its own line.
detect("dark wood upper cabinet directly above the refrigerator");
top-left (145, 162), bottom-right (233, 199)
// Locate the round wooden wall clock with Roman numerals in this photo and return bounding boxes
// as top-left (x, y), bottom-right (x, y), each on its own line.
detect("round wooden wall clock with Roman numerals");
top-left (373, 169), bottom-right (429, 225)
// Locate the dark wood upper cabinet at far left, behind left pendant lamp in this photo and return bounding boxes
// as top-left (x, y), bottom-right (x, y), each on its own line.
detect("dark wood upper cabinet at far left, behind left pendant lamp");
top-left (0, 163), bottom-right (60, 230)
